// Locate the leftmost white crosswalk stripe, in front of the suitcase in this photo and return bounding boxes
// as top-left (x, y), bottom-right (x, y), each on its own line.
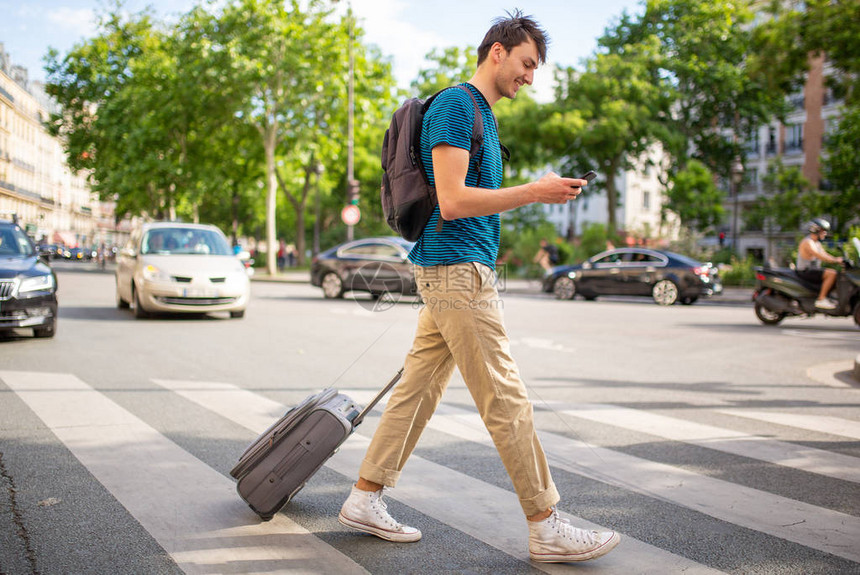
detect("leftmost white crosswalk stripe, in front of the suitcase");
top-left (0, 371), bottom-right (367, 574)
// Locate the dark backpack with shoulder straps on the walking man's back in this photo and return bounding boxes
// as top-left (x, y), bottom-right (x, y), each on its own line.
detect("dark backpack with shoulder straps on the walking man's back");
top-left (381, 85), bottom-right (510, 242)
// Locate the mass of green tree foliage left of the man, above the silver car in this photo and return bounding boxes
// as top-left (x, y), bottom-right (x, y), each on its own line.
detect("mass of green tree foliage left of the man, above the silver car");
top-left (47, 0), bottom-right (395, 268)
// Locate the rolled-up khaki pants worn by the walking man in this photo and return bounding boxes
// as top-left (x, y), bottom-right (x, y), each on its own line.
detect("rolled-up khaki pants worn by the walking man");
top-left (359, 263), bottom-right (559, 516)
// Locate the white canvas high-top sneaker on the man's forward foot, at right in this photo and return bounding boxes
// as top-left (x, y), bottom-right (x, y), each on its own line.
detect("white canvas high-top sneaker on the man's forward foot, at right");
top-left (528, 509), bottom-right (621, 563)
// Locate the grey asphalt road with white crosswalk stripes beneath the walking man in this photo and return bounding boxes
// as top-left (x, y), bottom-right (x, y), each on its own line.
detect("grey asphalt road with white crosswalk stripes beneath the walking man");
top-left (0, 263), bottom-right (860, 575)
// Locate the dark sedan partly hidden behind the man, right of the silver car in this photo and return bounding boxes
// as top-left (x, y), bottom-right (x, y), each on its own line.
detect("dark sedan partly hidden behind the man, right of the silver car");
top-left (311, 236), bottom-right (417, 298)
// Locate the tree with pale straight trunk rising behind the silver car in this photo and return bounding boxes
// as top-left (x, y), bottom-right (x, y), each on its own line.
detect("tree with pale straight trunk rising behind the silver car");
top-left (208, 0), bottom-right (343, 274)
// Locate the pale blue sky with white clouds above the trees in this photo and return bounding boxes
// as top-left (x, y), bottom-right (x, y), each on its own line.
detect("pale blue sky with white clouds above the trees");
top-left (0, 0), bottom-right (643, 100)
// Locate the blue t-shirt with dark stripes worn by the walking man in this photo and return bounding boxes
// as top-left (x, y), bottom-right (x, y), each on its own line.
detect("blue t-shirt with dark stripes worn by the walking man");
top-left (409, 83), bottom-right (502, 269)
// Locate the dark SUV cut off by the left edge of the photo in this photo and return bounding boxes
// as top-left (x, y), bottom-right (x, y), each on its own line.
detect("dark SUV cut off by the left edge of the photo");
top-left (0, 220), bottom-right (57, 337)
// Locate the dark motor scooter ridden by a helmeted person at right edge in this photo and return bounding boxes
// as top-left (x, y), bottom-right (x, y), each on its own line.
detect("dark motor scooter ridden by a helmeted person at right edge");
top-left (752, 238), bottom-right (860, 327)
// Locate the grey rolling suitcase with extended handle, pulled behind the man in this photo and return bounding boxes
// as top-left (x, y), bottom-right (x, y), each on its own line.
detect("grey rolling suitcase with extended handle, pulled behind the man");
top-left (230, 369), bottom-right (403, 521)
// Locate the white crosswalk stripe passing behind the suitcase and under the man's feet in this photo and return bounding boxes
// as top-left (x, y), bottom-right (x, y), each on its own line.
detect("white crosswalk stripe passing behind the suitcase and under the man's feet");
top-left (154, 379), bottom-right (719, 575)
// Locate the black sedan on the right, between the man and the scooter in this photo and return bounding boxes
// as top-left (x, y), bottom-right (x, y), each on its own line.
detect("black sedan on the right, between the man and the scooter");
top-left (543, 248), bottom-right (723, 305)
